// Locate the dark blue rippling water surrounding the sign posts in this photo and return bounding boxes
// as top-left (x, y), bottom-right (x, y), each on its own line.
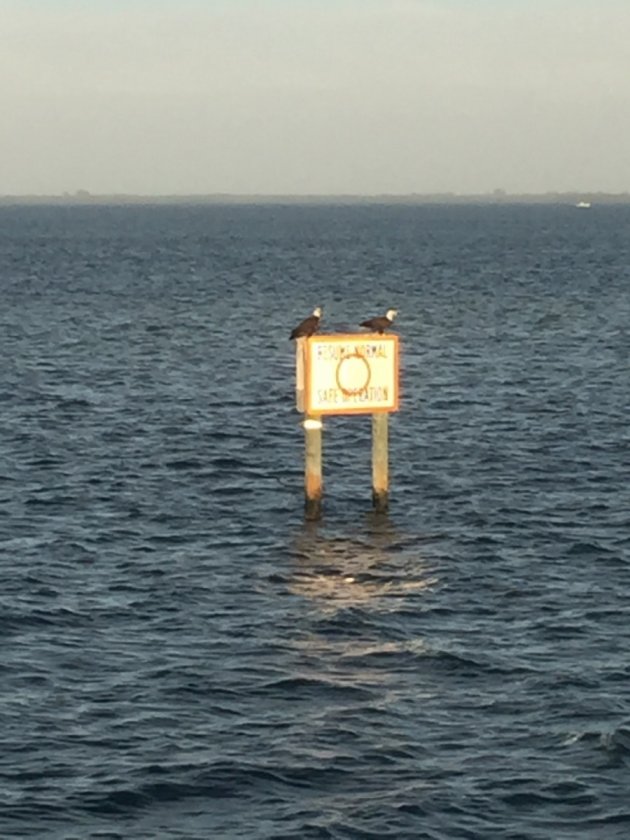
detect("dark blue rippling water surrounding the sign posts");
top-left (0, 206), bottom-right (630, 840)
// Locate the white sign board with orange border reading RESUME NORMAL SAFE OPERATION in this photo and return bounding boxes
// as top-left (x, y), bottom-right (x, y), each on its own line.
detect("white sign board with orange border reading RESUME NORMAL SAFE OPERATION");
top-left (304, 333), bottom-right (399, 414)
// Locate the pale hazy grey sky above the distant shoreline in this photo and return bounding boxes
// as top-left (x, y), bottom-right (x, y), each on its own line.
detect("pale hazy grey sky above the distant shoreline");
top-left (0, 0), bottom-right (630, 195)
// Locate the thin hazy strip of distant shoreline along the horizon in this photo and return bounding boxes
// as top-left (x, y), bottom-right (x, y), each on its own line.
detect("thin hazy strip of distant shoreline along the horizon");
top-left (0, 190), bottom-right (630, 206)
